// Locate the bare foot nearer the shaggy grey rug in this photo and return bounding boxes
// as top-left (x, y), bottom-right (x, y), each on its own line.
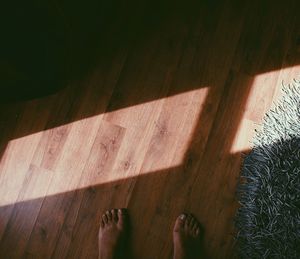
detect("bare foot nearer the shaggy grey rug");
top-left (173, 214), bottom-right (201, 259)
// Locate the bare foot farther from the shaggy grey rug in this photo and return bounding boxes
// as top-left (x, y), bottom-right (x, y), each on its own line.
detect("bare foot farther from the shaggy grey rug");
top-left (99, 209), bottom-right (128, 259)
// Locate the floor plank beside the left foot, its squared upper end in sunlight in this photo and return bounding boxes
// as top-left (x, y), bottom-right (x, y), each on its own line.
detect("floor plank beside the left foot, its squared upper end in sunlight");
top-left (52, 121), bottom-right (126, 258)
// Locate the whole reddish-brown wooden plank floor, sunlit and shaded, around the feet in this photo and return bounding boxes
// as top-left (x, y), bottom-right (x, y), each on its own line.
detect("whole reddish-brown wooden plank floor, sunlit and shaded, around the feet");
top-left (0, 1), bottom-right (300, 259)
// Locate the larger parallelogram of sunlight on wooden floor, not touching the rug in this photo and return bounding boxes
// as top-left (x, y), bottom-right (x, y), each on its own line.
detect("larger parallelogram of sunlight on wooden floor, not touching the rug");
top-left (0, 87), bottom-right (209, 207)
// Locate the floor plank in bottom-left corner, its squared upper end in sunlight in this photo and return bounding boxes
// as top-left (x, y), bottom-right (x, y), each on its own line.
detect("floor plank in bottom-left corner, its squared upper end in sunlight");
top-left (0, 165), bottom-right (53, 258)
